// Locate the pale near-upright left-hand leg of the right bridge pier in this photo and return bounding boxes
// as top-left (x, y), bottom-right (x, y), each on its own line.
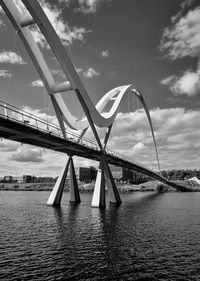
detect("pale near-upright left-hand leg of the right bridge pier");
top-left (91, 154), bottom-right (106, 208)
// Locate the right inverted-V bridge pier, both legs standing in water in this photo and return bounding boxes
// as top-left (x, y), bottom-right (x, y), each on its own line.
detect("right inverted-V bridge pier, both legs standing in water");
top-left (91, 153), bottom-right (122, 208)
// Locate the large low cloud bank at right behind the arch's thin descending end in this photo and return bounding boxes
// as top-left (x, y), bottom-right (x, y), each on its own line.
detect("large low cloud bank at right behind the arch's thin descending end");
top-left (101, 107), bottom-right (200, 169)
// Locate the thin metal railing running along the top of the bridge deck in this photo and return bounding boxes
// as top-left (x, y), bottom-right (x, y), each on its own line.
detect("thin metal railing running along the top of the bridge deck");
top-left (0, 101), bottom-right (158, 171)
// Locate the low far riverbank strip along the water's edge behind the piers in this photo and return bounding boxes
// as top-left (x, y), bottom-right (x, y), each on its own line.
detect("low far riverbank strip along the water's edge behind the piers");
top-left (0, 178), bottom-right (200, 192)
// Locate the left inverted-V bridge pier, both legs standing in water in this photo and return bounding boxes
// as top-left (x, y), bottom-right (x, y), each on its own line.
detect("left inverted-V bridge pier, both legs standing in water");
top-left (47, 156), bottom-right (81, 207)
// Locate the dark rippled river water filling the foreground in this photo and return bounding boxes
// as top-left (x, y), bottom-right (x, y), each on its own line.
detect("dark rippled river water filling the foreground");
top-left (0, 191), bottom-right (200, 281)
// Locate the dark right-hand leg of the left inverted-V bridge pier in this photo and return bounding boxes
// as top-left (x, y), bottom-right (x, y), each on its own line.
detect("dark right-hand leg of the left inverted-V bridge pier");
top-left (69, 156), bottom-right (81, 204)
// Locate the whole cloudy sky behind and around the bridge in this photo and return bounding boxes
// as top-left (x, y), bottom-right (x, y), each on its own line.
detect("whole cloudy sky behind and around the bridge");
top-left (0, 0), bottom-right (200, 177)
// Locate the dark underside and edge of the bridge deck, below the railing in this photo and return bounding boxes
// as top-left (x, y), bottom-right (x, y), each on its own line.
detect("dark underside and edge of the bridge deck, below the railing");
top-left (0, 107), bottom-right (189, 191)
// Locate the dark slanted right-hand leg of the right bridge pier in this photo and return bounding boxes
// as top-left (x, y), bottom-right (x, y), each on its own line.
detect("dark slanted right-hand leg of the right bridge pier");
top-left (105, 162), bottom-right (122, 205)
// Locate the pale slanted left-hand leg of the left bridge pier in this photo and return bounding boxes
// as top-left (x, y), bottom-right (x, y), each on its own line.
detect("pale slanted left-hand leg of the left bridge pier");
top-left (47, 157), bottom-right (70, 206)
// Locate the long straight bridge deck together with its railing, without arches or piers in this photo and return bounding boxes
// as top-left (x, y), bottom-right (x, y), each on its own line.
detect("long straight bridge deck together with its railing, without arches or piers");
top-left (0, 101), bottom-right (189, 191)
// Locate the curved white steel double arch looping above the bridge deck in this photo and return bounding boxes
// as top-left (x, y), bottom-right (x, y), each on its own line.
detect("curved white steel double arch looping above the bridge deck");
top-left (0, 0), bottom-right (159, 205)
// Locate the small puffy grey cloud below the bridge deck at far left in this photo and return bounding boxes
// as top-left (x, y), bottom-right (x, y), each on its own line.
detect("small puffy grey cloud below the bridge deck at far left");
top-left (10, 145), bottom-right (44, 162)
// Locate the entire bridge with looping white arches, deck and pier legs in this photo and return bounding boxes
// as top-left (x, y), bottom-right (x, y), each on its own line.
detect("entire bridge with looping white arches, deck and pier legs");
top-left (0, 0), bottom-right (191, 208)
